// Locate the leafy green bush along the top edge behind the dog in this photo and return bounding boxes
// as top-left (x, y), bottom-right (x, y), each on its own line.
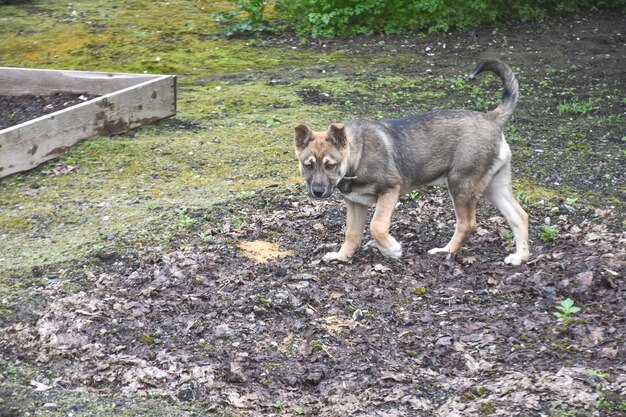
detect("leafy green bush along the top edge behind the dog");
top-left (276, 0), bottom-right (626, 37)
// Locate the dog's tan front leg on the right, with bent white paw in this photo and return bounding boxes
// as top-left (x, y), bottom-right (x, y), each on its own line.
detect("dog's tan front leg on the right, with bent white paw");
top-left (370, 187), bottom-right (402, 259)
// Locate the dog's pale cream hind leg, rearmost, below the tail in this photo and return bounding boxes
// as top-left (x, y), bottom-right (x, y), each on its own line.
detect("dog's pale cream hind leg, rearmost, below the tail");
top-left (486, 163), bottom-right (530, 265)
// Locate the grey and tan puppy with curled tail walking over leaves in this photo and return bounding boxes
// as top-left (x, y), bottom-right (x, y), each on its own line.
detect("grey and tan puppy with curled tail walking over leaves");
top-left (294, 58), bottom-right (529, 265)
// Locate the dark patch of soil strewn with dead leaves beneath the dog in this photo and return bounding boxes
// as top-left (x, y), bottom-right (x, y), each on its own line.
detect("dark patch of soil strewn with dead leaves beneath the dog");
top-left (0, 189), bottom-right (626, 416)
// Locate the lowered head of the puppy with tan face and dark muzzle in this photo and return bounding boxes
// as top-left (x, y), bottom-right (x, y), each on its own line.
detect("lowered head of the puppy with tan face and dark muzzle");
top-left (294, 124), bottom-right (349, 198)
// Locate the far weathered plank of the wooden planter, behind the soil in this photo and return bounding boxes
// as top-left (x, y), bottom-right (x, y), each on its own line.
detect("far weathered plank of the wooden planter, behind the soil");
top-left (0, 67), bottom-right (156, 96)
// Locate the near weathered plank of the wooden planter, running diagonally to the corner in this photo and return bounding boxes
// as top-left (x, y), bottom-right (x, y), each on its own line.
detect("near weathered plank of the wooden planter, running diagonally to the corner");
top-left (0, 75), bottom-right (176, 177)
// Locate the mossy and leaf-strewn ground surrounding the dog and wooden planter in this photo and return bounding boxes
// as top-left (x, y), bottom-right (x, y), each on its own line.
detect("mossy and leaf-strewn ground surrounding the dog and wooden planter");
top-left (0, 1), bottom-right (626, 416)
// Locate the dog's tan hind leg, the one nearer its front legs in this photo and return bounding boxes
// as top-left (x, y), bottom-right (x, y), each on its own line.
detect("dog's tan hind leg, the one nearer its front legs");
top-left (428, 186), bottom-right (478, 255)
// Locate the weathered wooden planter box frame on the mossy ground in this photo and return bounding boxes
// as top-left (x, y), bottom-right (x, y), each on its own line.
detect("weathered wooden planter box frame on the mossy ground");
top-left (0, 67), bottom-right (176, 177)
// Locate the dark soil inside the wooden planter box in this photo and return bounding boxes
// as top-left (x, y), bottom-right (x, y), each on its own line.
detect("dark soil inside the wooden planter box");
top-left (0, 92), bottom-right (98, 130)
